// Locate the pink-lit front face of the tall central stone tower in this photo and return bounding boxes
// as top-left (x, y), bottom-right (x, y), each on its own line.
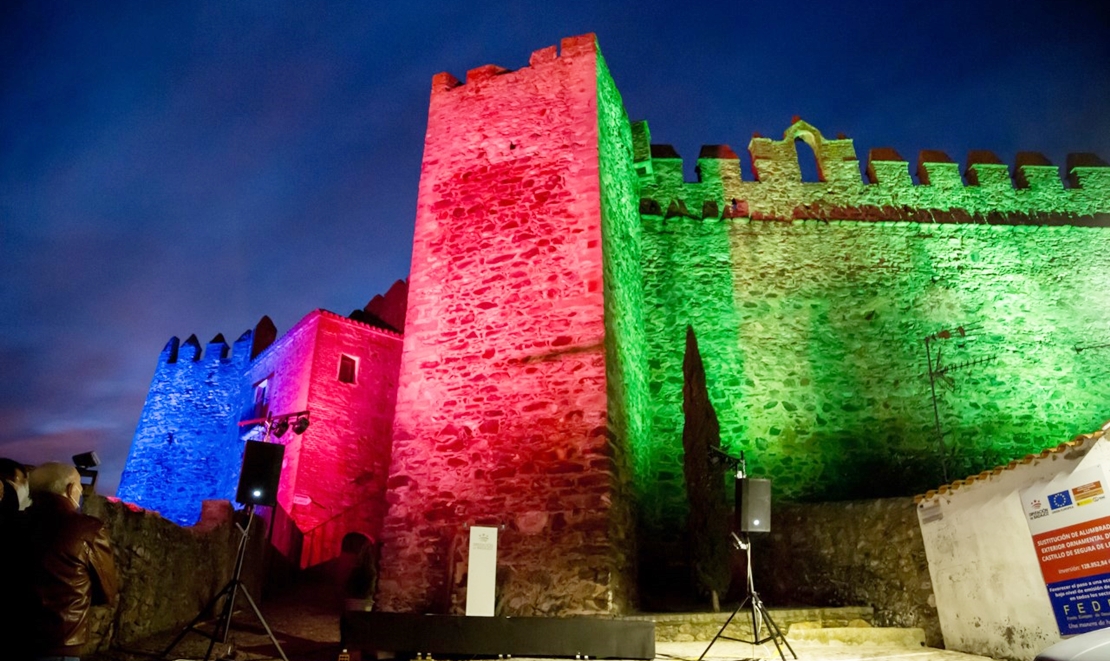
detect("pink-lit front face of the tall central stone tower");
top-left (377, 34), bottom-right (626, 614)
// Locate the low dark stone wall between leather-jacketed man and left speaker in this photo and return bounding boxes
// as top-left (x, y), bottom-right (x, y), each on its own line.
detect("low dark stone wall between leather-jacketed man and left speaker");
top-left (84, 497), bottom-right (255, 652)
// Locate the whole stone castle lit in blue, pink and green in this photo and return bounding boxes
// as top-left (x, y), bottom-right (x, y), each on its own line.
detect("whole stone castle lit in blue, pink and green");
top-left (119, 34), bottom-right (1110, 614)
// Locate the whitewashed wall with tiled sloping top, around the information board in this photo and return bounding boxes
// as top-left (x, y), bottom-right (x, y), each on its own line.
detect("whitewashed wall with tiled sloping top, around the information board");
top-left (917, 432), bottom-right (1110, 661)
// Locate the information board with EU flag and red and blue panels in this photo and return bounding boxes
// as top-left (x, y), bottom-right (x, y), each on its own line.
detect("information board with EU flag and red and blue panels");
top-left (1021, 465), bottom-right (1110, 635)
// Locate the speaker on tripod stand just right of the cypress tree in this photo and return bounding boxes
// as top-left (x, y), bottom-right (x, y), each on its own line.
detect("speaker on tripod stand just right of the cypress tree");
top-left (697, 448), bottom-right (798, 661)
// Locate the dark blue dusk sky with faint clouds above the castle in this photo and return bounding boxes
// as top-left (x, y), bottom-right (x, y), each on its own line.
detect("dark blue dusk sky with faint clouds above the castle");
top-left (0, 0), bottom-right (1110, 494)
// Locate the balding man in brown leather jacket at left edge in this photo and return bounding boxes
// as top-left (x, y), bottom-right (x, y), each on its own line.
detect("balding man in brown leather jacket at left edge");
top-left (18, 463), bottom-right (117, 659)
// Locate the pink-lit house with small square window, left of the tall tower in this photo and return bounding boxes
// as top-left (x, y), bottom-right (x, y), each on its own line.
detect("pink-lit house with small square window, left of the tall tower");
top-left (249, 310), bottom-right (401, 567)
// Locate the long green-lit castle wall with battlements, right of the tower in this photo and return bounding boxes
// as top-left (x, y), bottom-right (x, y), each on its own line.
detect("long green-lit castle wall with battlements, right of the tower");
top-left (634, 121), bottom-right (1110, 522)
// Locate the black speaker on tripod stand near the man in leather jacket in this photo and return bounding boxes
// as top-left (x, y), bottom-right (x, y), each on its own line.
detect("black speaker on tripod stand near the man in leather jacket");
top-left (162, 439), bottom-right (289, 661)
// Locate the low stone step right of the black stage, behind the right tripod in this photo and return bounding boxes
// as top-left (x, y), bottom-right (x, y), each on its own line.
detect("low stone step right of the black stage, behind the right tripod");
top-left (627, 607), bottom-right (875, 642)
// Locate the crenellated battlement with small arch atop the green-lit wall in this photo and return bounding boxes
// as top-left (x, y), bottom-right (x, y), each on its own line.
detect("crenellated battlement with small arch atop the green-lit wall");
top-left (633, 118), bottom-right (1110, 226)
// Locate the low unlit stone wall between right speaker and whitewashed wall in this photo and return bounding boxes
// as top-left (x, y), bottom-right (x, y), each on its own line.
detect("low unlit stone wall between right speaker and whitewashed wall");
top-left (753, 498), bottom-right (944, 647)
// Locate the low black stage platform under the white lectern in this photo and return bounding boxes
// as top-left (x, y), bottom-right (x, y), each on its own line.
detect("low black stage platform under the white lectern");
top-left (342, 611), bottom-right (655, 659)
